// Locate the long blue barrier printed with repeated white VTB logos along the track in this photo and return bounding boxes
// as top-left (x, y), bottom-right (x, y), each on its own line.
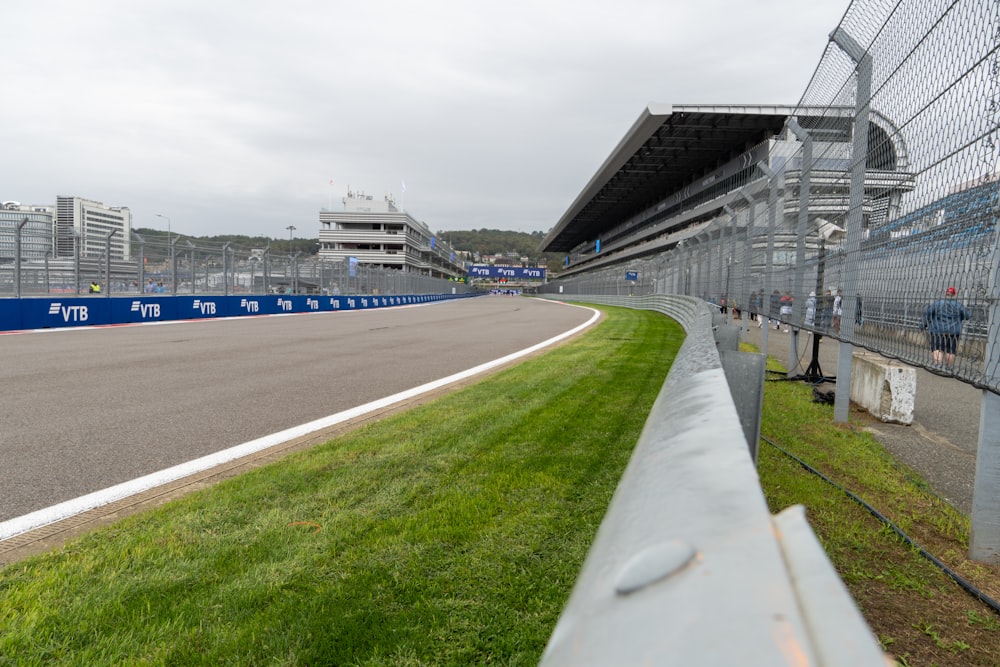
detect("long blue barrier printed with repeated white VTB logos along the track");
top-left (0, 294), bottom-right (479, 331)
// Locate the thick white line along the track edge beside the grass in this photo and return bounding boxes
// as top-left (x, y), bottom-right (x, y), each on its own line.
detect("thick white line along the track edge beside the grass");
top-left (0, 302), bottom-right (600, 540)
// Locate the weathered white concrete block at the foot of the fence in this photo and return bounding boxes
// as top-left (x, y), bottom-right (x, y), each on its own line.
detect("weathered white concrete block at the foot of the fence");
top-left (851, 354), bottom-right (917, 424)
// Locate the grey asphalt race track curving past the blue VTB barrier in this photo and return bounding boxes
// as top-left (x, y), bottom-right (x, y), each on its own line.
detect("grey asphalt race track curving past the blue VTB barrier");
top-left (0, 296), bottom-right (592, 521)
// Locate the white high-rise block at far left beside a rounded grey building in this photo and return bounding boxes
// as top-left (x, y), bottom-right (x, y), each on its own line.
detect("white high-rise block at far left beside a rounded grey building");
top-left (53, 197), bottom-right (132, 260)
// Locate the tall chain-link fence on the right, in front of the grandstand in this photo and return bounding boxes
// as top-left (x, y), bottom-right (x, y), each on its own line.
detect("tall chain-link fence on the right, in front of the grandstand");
top-left (543, 0), bottom-right (1000, 392)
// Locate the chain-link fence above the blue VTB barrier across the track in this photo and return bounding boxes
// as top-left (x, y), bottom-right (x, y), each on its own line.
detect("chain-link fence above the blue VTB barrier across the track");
top-left (0, 234), bottom-right (468, 297)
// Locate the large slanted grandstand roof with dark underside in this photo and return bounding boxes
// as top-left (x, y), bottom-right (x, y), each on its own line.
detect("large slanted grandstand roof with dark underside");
top-left (541, 104), bottom-right (802, 252)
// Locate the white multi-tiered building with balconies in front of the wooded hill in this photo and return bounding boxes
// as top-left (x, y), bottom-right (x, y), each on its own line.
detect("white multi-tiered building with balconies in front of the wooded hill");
top-left (319, 192), bottom-right (465, 278)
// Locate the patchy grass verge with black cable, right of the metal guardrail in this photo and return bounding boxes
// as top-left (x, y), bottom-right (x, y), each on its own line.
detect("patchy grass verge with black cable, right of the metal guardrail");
top-left (758, 350), bottom-right (1000, 667)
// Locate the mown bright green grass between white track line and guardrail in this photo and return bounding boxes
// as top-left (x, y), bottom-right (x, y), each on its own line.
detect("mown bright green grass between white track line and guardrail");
top-left (0, 309), bottom-right (683, 666)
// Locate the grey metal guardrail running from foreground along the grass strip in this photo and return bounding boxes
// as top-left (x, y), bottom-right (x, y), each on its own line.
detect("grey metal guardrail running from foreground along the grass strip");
top-left (541, 295), bottom-right (885, 667)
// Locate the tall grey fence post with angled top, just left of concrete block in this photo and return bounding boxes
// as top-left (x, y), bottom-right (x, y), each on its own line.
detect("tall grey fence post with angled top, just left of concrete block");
top-left (830, 28), bottom-right (872, 423)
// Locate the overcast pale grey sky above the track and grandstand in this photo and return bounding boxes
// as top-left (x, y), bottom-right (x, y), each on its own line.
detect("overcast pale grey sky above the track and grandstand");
top-left (0, 0), bottom-right (849, 238)
